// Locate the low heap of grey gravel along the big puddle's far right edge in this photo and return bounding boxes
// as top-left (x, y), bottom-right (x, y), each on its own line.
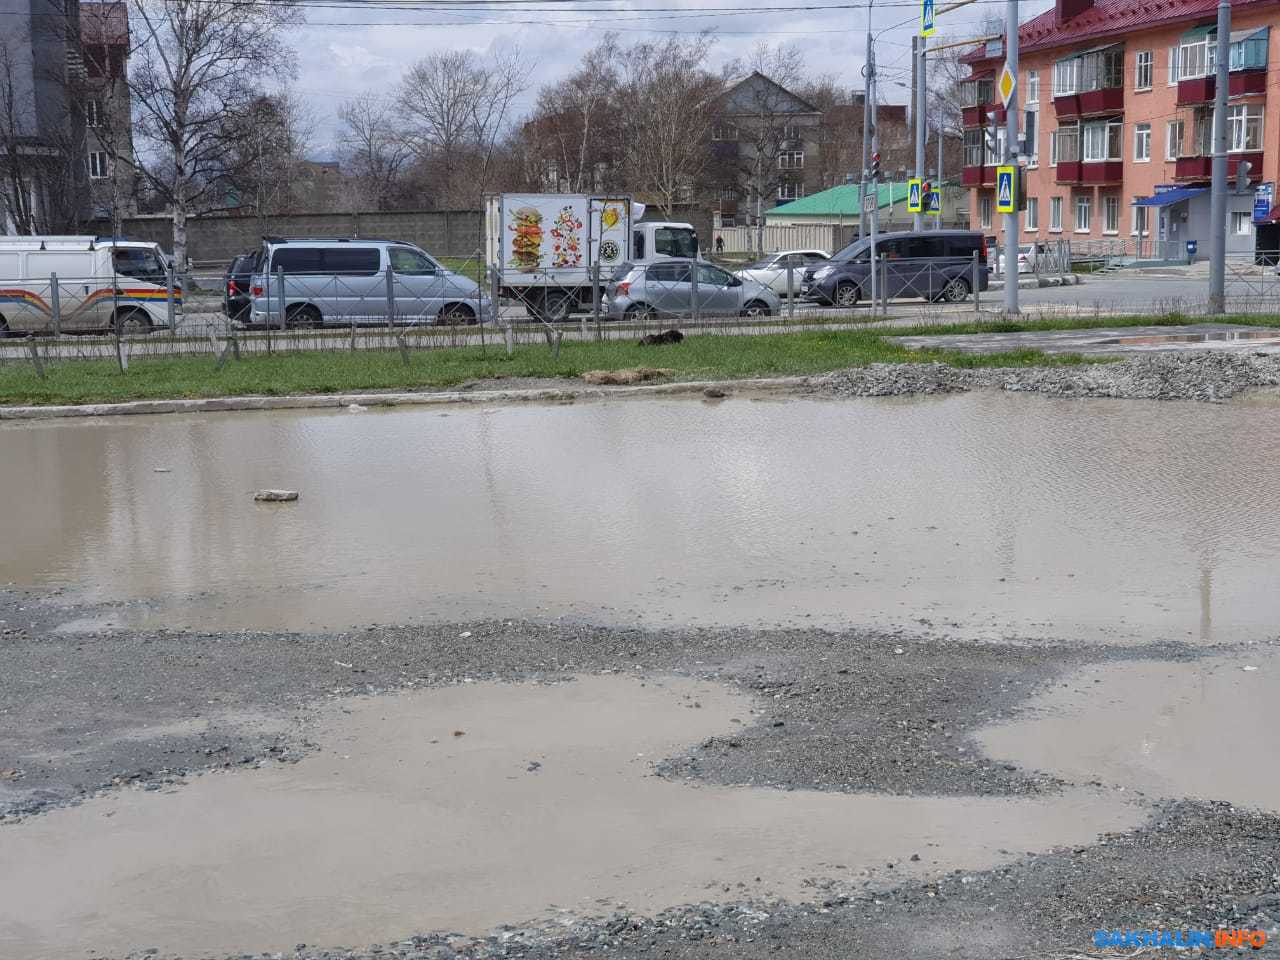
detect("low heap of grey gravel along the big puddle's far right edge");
top-left (806, 351), bottom-right (1280, 402)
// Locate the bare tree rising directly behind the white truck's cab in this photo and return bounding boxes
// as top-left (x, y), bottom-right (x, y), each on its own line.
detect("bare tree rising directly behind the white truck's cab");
top-left (622, 33), bottom-right (722, 216)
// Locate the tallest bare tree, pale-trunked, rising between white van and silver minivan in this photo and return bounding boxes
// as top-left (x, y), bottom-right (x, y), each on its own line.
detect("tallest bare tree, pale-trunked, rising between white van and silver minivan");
top-left (128, 0), bottom-right (298, 269)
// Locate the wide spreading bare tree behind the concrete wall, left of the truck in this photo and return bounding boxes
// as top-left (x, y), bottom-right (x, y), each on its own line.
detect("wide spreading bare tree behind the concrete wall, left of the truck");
top-left (398, 49), bottom-right (527, 206)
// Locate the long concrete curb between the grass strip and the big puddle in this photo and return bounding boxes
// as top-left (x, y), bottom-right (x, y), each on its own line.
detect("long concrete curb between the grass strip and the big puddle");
top-left (0, 376), bottom-right (809, 421)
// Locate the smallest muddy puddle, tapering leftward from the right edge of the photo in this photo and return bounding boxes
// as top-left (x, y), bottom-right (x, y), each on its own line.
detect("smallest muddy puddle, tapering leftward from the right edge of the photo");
top-left (978, 645), bottom-right (1280, 813)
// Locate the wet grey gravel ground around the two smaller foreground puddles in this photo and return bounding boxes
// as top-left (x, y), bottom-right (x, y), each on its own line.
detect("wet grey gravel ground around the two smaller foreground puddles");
top-left (0, 593), bottom-right (1280, 960)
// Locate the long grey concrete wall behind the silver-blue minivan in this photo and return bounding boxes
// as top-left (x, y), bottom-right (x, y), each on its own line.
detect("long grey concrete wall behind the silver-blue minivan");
top-left (92, 210), bottom-right (483, 264)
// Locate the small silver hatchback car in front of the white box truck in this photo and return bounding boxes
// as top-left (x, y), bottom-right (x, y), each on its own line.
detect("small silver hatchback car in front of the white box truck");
top-left (605, 259), bottom-right (782, 320)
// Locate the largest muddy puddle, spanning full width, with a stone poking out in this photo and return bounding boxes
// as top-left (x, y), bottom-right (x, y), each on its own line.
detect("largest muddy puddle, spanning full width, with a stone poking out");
top-left (0, 392), bottom-right (1280, 641)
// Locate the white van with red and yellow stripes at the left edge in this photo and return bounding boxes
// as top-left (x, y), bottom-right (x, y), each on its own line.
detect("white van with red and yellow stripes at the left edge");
top-left (0, 237), bottom-right (182, 337)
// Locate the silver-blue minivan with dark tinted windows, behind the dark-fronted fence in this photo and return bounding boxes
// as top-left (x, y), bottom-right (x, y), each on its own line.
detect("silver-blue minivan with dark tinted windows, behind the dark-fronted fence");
top-left (248, 237), bottom-right (493, 326)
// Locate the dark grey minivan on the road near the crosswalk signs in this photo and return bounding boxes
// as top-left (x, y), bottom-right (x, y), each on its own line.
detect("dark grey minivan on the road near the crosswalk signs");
top-left (800, 230), bottom-right (987, 307)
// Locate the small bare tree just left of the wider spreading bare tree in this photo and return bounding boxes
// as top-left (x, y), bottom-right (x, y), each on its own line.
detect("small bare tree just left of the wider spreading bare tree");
top-left (338, 93), bottom-right (413, 210)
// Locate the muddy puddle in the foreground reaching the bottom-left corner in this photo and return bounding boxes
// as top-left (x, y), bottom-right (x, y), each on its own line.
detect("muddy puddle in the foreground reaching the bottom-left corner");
top-left (0, 676), bottom-right (1143, 960)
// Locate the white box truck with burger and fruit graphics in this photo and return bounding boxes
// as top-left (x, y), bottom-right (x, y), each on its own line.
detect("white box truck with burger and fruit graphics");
top-left (485, 193), bottom-right (698, 323)
